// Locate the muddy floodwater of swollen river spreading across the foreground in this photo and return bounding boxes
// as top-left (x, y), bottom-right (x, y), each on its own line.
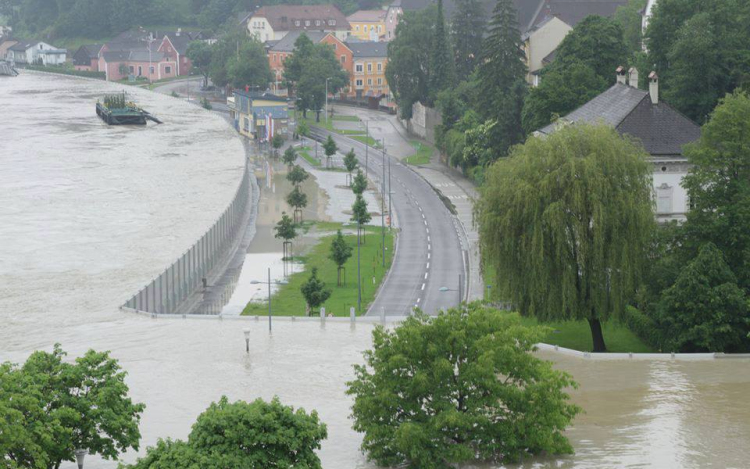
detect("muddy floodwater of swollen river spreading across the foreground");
top-left (0, 73), bottom-right (750, 469)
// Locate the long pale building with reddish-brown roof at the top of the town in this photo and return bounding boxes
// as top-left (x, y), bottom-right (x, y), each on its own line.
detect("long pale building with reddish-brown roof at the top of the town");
top-left (247, 5), bottom-right (349, 41)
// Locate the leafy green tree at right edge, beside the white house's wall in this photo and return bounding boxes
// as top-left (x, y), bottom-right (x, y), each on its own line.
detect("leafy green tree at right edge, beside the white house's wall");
top-left (683, 92), bottom-right (750, 292)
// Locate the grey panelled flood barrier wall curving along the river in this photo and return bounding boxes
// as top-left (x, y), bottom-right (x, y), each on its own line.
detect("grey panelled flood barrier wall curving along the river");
top-left (122, 161), bottom-right (250, 314)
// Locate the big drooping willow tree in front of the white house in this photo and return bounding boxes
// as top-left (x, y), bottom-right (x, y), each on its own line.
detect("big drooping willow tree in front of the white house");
top-left (475, 125), bottom-right (655, 352)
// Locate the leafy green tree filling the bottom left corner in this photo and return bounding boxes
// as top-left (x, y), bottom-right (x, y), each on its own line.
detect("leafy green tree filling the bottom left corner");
top-left (0, 345), bottom-right (145, 468)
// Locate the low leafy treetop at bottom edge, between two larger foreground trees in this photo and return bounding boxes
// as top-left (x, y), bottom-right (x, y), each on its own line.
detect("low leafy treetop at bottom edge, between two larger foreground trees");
top-left (121, 397), bottom-right (328, 469)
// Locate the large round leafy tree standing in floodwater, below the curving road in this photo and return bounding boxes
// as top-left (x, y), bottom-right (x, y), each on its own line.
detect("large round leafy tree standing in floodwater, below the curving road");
top-left (347, 303), bottom-right (580, 469)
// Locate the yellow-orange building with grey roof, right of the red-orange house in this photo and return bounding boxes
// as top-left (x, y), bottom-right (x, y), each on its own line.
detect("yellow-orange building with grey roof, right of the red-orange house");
top-left (346, 42), bottom-right (391, 99)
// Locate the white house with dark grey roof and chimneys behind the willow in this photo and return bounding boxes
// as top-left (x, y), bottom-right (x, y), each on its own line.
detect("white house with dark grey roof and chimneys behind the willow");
top-left (537, 67), bottom-right (701, 221)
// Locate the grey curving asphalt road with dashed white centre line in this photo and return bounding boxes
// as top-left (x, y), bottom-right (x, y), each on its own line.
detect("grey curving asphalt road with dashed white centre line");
top-left (311, 128), bottom-right (467, 316)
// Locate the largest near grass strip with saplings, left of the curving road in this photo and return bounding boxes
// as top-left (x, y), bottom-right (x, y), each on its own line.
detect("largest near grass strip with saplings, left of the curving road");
top-left (242, 223), bottom-right (393, 317)
